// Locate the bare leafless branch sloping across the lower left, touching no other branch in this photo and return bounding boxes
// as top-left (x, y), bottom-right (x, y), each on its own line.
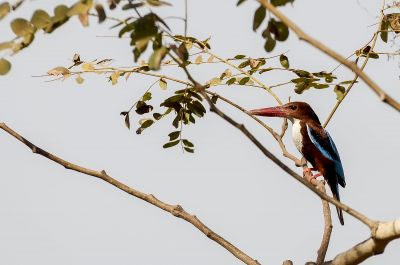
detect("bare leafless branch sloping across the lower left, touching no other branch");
top-left (0, 123), bottom-right (260, 265)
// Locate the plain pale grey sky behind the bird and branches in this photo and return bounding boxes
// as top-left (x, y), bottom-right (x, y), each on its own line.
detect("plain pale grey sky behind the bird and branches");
top-left (0, 0), bottom-right (400, 265)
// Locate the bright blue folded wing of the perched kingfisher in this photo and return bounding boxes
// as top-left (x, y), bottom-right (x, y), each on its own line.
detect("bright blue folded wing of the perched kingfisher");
top-left (307, 126), bottom-right (346, 187)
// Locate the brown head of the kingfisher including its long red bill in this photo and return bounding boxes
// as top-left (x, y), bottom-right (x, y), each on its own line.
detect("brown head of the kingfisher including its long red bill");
top-left (248, 102), bottom-right (320, 124)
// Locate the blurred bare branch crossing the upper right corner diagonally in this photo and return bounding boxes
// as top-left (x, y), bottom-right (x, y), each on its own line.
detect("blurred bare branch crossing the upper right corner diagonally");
top-left (257, 0), bottom-right (400, 111)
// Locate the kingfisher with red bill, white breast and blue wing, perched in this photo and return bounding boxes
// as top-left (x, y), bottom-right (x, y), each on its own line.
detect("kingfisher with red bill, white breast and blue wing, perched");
top-left (248, 102), bottom-right (346, 225)
